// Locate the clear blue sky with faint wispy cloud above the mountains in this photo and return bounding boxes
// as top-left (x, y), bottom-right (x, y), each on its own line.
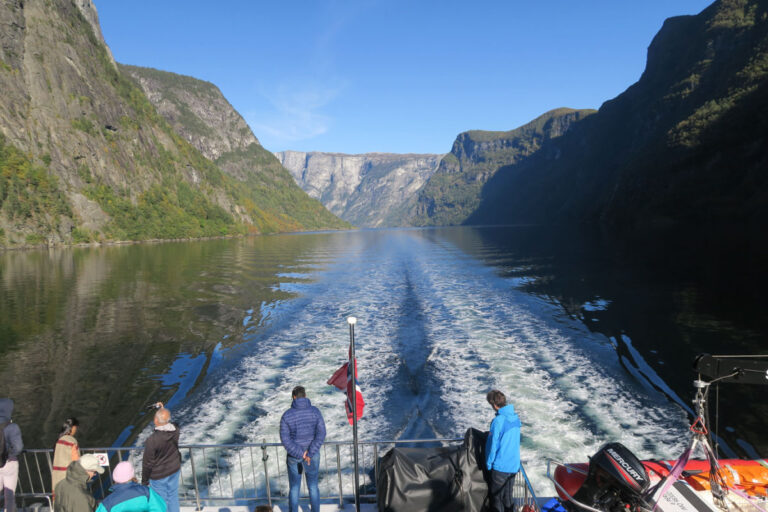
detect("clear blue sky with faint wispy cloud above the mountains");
top-left (94, 0), bottom-right (710, 153)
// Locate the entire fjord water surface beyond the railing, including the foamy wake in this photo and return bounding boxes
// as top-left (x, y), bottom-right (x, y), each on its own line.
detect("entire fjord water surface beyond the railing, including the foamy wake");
top-left (0, 227), bottom-right (768, 485)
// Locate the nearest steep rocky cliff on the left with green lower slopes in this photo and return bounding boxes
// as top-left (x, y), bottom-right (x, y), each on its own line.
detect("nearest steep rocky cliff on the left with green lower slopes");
top-left (0, 0), bottom-right (343, 246)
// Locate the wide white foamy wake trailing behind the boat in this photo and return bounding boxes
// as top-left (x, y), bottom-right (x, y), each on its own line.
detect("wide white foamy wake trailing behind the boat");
top-left (141, 231), bottom-right (686, 493)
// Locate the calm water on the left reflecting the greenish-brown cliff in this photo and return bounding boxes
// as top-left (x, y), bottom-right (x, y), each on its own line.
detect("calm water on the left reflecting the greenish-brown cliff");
top-left (0, 235), bottom-right (328, 447)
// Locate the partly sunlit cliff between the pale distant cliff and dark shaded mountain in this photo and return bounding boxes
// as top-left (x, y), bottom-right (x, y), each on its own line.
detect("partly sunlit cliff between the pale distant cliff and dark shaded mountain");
top-left (411, 108), bottom-right (595, 226)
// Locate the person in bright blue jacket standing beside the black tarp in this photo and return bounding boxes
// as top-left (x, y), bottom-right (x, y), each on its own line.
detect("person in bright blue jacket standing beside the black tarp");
top-left (485, 389), bottom-right (520, 512)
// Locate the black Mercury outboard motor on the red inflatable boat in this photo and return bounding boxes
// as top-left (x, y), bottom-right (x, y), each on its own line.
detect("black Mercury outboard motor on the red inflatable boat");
top-left (573, 443), bottom-right (650, 512)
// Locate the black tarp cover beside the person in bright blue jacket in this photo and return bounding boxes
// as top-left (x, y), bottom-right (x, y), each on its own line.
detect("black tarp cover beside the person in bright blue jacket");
top-left (376, 428), bottom-right (488, 512)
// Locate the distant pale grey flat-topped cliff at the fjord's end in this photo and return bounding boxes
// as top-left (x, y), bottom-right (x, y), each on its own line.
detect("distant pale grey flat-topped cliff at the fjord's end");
top-left (276, 151), bottom-right (442, 227)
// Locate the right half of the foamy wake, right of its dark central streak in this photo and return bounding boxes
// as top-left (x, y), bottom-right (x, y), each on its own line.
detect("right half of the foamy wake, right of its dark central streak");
top-left (390, 234), bottom-right (687, 489)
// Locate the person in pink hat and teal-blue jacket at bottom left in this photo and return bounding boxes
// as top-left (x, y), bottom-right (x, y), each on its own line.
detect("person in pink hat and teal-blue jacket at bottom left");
top-left (96, 461), bottom-right (166, 512)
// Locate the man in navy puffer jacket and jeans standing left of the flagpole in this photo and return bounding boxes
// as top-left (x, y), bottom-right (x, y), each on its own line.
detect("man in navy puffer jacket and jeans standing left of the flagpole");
top-left (280, 386), bottom-right (325, 512)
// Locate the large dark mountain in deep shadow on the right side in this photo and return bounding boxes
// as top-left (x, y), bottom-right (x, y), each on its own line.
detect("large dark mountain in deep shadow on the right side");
top-left (467, 0), bottom-right (768, 225)
